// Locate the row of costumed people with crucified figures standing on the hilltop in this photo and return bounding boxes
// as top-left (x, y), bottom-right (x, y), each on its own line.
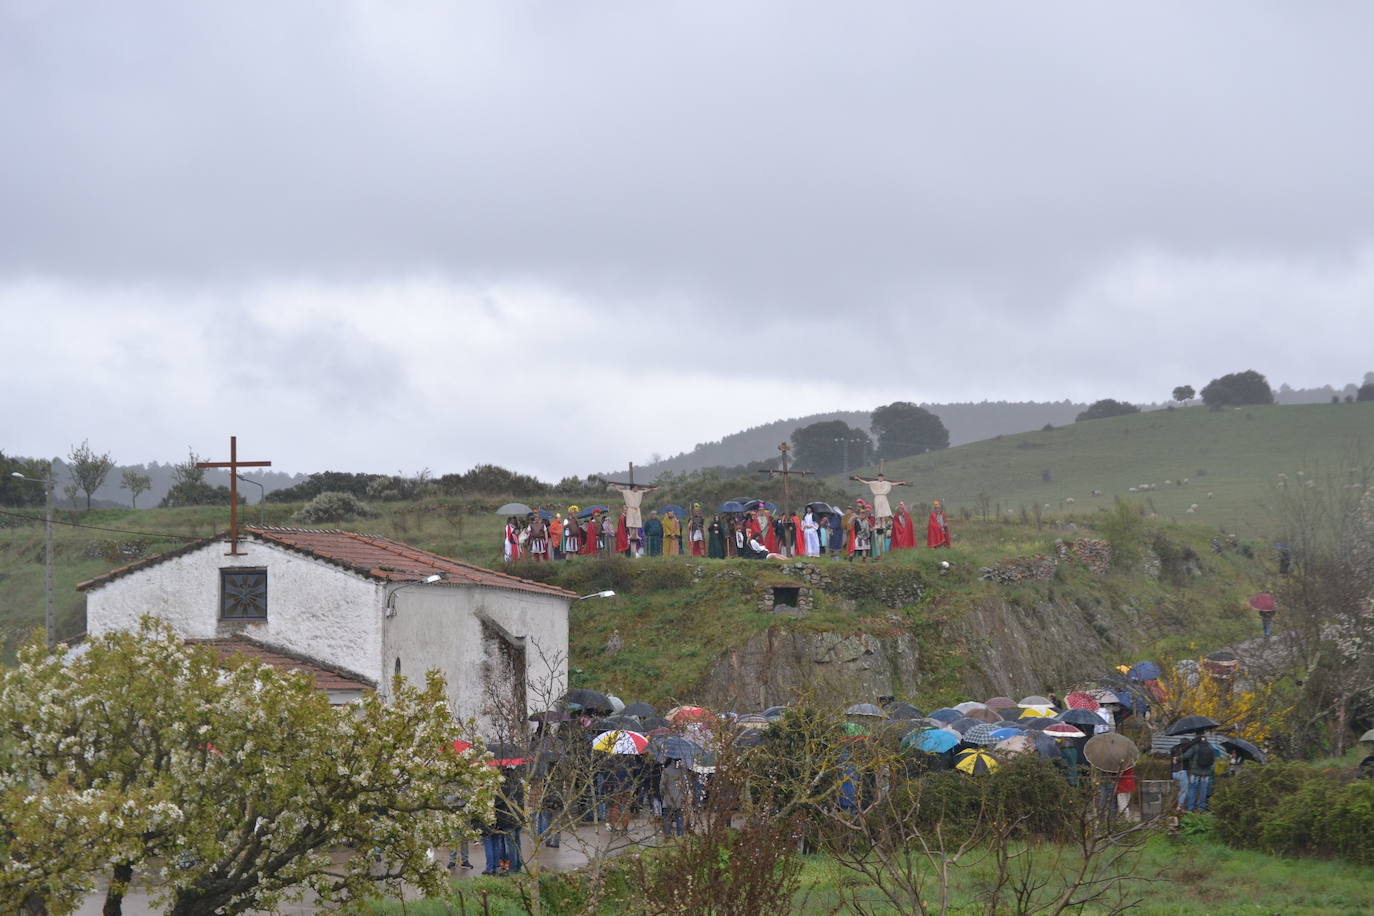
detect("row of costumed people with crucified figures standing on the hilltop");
top-left (500, 474), bottom-right (951, 562)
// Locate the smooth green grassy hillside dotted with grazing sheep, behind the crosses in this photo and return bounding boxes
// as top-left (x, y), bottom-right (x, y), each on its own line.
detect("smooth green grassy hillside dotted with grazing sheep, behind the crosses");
top-left (827, 404), bottom-right (1374, 536)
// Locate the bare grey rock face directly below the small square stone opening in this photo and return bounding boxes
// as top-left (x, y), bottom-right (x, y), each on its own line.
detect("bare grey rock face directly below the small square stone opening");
top-left (702, 626), bottom-right (918, 710)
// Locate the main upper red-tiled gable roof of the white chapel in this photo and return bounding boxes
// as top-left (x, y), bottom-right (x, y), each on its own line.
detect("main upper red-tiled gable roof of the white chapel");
top-left (77, 526), bottom-right (577, 597)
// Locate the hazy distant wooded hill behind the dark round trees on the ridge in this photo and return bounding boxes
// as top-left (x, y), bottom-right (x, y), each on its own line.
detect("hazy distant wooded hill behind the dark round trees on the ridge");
top-left (618, 401), bottom-right (1087, 481)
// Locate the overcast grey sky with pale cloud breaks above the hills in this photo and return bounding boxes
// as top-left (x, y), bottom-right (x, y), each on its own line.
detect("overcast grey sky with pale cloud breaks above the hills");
top-left (0, 0), bottom-right (1374, 478)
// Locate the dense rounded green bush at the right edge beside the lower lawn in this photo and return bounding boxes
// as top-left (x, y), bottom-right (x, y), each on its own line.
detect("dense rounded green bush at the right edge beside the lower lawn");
top-left (1209, 764), bottom-right (1374, 865)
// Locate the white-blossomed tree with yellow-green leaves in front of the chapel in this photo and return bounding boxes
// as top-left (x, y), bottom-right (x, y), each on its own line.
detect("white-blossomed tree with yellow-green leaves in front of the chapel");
top-left (0, 621), bottom-right (496, 916)
